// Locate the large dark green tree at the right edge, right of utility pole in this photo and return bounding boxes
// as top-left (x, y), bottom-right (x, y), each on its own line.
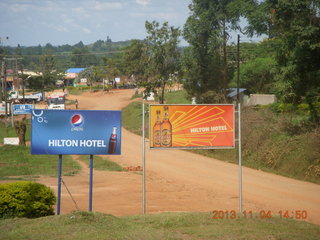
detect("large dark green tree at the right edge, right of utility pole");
top-left (247, 0), bottom-right (320, 103)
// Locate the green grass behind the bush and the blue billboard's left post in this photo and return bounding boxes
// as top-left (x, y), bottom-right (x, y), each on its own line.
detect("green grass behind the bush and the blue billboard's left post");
top-left (0, 145), bottom-right (81, 180)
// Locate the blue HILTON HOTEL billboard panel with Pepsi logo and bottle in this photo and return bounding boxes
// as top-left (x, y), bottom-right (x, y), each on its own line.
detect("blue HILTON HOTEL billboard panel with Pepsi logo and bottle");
top-left (31, 109), bottom-right (121, 155)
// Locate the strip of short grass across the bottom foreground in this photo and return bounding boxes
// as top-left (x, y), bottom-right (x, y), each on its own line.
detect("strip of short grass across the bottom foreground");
top-left (0, 212), bottom-right (320, 240)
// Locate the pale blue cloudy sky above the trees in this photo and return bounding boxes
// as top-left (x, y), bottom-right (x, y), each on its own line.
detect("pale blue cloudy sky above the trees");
top-left (0, 0), bottom-right (264, 46)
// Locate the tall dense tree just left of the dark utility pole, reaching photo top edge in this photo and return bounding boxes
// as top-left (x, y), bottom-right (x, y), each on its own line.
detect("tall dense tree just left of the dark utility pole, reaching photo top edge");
top-left (183, 0), bottom-right (239, 102)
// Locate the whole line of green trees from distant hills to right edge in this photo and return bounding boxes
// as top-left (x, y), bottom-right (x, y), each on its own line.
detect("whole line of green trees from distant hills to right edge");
top-left (1, 0), bottom-right (320, 110)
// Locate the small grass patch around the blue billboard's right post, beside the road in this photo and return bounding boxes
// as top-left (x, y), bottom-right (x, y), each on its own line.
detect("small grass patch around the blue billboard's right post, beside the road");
top-left (79, 155), bottom-right (124, 172)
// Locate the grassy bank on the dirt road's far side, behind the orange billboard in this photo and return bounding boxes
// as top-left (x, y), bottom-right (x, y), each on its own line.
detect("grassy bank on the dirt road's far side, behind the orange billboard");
top-left (122, 91), bottom-right (320, 184)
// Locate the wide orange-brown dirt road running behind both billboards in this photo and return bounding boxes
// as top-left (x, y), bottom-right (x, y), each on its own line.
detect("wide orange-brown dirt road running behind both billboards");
top-left (36, 90), bottom-right (320, 224)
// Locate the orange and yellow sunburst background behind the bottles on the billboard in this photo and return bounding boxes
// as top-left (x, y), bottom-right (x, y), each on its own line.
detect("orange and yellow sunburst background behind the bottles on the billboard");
top-left (150, 105), bottom-right (234, 147)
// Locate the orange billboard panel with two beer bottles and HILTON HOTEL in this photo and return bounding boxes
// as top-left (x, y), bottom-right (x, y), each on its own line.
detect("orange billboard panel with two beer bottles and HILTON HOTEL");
top-left (149, 104), bottom-right (235, 149)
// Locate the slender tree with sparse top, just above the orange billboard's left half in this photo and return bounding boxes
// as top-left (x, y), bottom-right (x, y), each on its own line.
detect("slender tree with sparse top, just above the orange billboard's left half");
top-left (145, 21), bottom-right (180, 104)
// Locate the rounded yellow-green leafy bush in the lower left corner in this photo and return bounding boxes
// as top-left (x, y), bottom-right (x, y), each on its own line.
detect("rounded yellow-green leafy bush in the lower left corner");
top-left (0, 181), bottom-right (56, 218)
